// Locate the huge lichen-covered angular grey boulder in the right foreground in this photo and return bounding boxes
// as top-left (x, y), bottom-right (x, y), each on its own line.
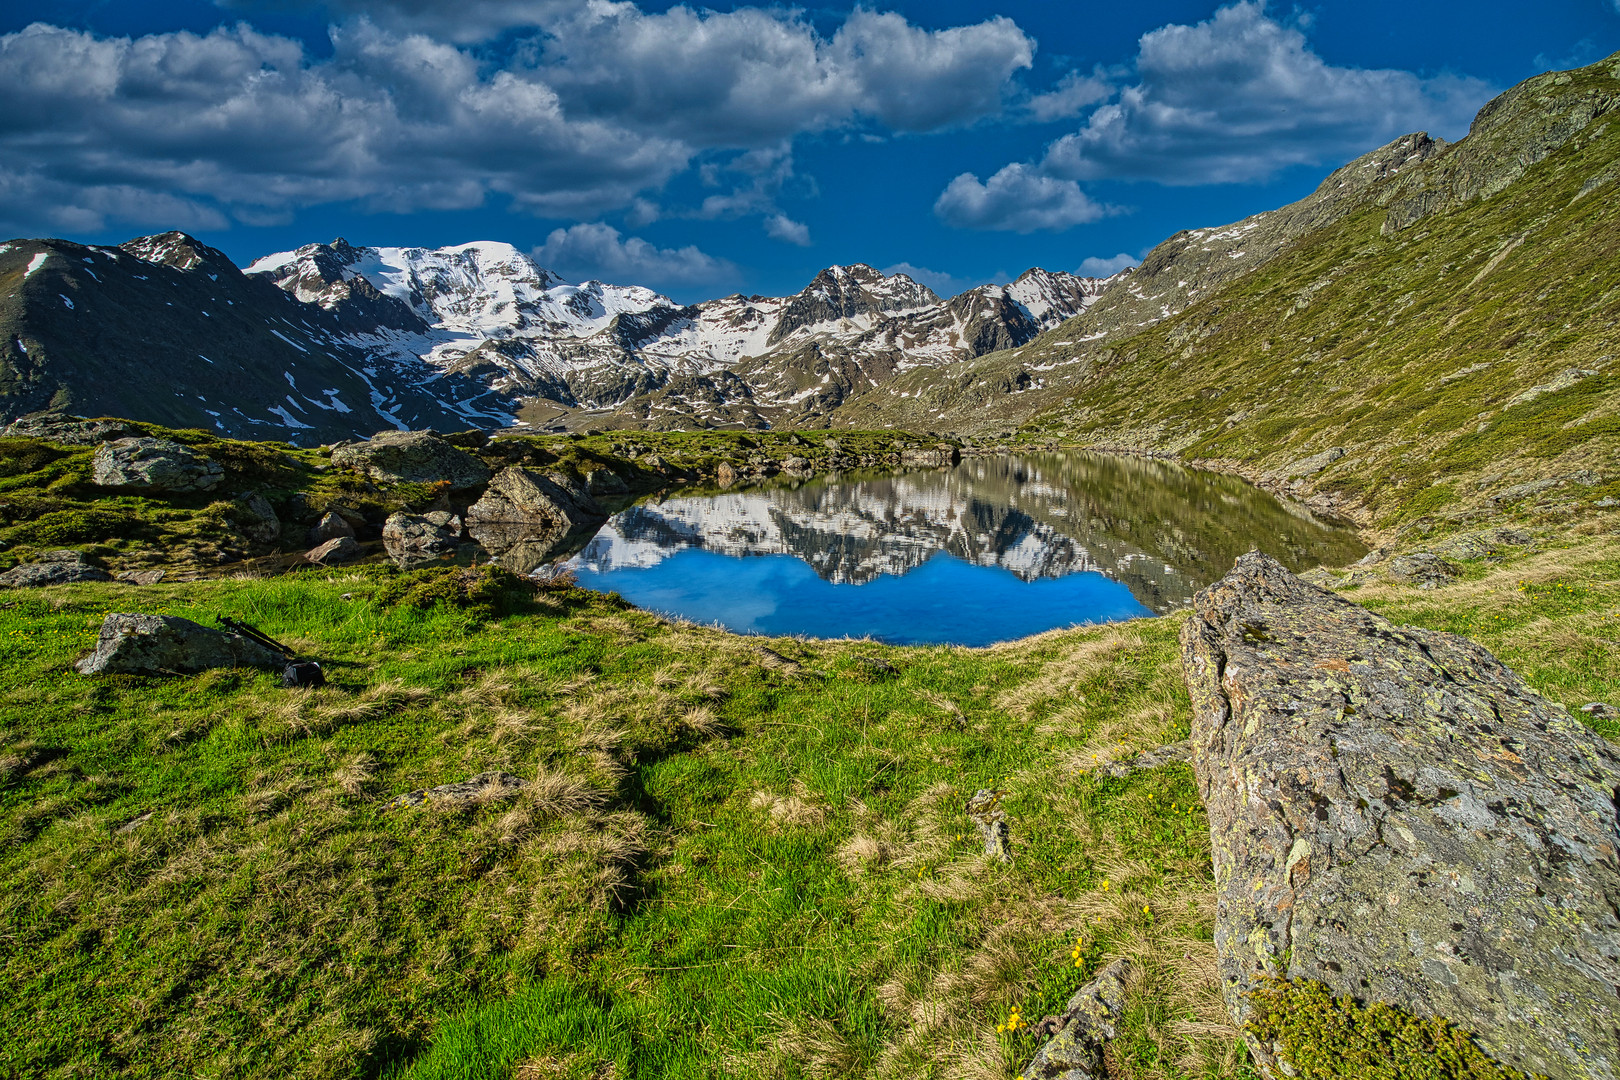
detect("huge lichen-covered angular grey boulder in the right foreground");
top-left (1181, 552), bottom-right (1620, 1080)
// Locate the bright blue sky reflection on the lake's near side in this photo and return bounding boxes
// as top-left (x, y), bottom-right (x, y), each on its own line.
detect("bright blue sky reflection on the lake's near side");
top-left (577, 547), bottom-right (1153, 646)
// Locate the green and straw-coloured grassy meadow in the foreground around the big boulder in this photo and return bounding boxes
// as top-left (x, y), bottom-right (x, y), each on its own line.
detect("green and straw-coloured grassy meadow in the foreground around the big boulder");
top-left (0, 501), bottom-right (1620, 1080)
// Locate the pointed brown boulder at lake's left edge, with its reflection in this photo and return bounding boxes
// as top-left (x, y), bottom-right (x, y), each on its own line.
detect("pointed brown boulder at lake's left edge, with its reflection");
top-left (467, 465), bottom-right (608, 573)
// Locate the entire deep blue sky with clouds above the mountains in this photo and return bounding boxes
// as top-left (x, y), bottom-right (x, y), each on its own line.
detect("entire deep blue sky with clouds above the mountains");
top-left (0, 0), bottom-right (1620, 301)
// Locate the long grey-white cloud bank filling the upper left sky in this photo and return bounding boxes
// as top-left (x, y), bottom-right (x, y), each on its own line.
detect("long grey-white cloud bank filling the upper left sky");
top-left (0, 0), bottom-right (1034, 230)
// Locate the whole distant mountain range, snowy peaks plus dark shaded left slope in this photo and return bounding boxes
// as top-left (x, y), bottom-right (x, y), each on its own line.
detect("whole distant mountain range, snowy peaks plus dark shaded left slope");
top-left (0, 232), bottom-right (1110, 444)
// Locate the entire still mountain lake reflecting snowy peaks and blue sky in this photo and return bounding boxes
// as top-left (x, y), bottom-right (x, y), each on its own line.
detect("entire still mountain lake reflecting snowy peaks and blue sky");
top-left (565, 452), bottom-right (1366, 646)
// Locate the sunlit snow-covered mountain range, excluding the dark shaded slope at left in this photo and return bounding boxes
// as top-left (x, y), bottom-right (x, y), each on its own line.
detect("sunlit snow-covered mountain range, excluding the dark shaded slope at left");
top-left (248, 240), bottom-right (1108, 426)
